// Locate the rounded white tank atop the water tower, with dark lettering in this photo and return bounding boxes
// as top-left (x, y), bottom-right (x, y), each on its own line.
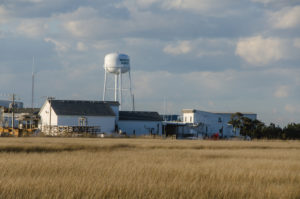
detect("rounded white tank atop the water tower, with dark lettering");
top-left (104, 53), bottom-right (130, 74)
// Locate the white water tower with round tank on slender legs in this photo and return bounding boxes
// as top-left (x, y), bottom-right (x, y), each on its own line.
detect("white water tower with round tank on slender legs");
top-left (103, 53), bottom-right (134, 110)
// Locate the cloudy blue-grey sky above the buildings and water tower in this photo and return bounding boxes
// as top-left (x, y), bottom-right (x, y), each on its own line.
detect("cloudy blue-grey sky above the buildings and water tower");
top-left (0, 0), bottom-right (300, 126)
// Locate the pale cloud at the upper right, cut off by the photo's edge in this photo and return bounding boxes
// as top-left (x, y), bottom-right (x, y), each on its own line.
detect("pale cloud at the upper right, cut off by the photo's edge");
top-left (269, 6), bottom-right (300, 29)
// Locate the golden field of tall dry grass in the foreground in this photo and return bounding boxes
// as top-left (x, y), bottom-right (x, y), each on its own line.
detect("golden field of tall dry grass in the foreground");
top-left (0, 138), bottom-right (300, 199)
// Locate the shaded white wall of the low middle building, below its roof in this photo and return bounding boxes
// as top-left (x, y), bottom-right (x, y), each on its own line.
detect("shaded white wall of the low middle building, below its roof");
top-left (118, 120), bottom-right (162, 136)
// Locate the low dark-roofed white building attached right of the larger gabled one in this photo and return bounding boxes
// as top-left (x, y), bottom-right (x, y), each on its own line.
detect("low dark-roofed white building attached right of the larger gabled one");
top-left (118, 111), bottom-right (162, 136)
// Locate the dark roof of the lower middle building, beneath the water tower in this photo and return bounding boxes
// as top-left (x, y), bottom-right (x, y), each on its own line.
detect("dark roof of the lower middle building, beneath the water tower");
top-left (119, 111), bottom-right (162, 121)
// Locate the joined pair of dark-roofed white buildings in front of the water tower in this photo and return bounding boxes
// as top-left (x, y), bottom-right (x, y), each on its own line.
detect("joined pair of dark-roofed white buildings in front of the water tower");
top-left (39, 99), bottom-right (162, 136)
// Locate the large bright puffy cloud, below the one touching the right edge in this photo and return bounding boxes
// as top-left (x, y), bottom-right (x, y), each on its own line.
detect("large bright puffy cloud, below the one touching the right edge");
top-left (235, 36), bottom-right (284, 66)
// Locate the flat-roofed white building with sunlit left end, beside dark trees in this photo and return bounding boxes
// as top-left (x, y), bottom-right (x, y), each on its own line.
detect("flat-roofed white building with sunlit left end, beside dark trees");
top-left (182, 109), bottom-right (257, 137)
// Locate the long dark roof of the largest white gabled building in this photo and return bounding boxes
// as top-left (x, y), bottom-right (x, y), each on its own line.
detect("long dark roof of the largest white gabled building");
top-left (51, 100), bottom-right (115, 116)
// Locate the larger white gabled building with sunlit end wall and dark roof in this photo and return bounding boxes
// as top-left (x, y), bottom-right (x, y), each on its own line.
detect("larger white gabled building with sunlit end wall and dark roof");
top-left (39, 99), bottom-right (119, 133)
